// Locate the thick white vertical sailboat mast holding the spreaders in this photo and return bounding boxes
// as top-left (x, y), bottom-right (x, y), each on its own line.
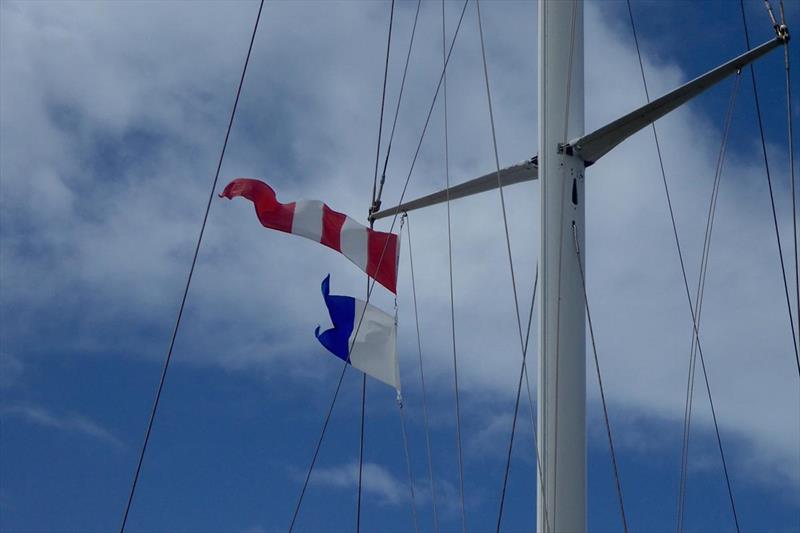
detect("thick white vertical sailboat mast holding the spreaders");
top-left (537, 0), bottom-right (586, 533)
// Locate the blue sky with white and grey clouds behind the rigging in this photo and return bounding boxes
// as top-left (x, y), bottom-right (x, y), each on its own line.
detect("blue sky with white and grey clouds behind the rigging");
top-left (0, 0), bottom-right (800, 532)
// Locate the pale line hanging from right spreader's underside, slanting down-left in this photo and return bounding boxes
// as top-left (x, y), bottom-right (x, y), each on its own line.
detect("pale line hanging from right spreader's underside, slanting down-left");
top-left (677, 75), bottom-right (741, 531)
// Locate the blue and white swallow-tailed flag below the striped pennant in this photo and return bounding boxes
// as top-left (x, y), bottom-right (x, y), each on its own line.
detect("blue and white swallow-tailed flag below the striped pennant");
top-left (314, 274), bottom-right (400, 392)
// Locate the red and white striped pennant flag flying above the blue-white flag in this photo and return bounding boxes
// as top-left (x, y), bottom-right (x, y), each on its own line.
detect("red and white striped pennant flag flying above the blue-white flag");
top-left (220, 178), bottom-right (400, 294)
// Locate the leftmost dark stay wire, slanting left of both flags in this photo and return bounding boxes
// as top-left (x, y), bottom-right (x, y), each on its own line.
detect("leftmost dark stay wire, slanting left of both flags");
top-left (120, 0), bottom-right (264, 533)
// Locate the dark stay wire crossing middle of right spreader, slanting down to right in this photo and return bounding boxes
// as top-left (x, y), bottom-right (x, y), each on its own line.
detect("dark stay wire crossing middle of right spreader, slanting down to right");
top-left (626, 0), bottom-right (740, 532)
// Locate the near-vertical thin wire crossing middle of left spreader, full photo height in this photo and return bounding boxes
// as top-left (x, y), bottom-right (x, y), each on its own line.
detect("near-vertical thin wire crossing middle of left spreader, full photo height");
top-left (442, 0), bottom-right (467, 533)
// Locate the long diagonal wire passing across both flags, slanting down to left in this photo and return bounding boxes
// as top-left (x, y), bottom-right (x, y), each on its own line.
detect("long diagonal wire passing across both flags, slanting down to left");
top-left (289, 0), bottom-right (469, 533)
